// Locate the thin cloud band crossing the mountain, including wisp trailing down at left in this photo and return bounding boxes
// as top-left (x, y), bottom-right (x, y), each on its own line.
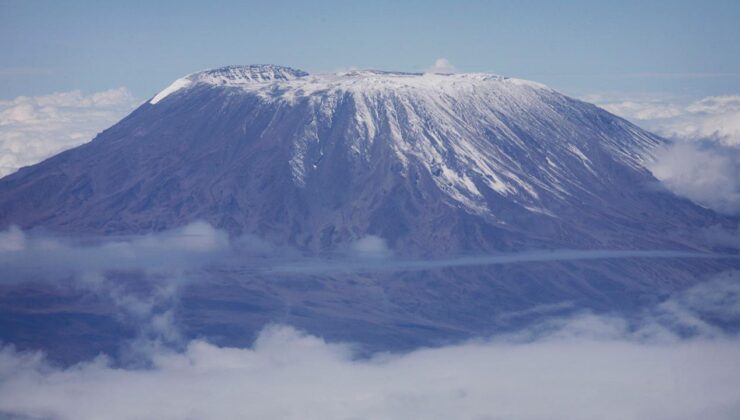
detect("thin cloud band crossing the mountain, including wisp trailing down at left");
top-left (0, 222), bottom-right (738, 348)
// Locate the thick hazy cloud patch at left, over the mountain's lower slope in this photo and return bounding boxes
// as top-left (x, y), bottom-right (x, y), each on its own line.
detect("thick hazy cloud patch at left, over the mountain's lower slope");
top-left (0, 222), bottom-right (231, 284)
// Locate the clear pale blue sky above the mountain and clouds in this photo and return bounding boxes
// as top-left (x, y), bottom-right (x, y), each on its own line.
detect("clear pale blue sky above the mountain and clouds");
top-left (0, 0), bottom-right (740, 98)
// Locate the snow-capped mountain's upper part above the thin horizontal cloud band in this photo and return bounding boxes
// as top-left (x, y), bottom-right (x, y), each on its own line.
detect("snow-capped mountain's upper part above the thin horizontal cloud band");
top-left (0, 65), bottom-right (716, 254)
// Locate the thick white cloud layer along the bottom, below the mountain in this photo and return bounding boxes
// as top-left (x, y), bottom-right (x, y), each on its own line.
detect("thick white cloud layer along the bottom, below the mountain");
top-left (0, 273), bottom-right (740, 420)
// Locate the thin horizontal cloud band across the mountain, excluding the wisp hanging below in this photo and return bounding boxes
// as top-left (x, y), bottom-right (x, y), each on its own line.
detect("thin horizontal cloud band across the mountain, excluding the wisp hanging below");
top-left (0, 225), bottom-right (724, 284)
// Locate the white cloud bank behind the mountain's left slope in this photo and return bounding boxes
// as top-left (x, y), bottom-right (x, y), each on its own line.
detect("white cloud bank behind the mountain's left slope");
top-left (0, 87), bottom-right (137, 176)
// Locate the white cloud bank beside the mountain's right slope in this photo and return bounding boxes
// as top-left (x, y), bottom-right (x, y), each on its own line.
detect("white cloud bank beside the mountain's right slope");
top-left (584, 95), bottom-right (740, 214)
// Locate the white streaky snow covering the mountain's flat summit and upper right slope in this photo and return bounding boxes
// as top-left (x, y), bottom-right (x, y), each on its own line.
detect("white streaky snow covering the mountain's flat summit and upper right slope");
top-left (143, 65), bottom-right (661, 218)
